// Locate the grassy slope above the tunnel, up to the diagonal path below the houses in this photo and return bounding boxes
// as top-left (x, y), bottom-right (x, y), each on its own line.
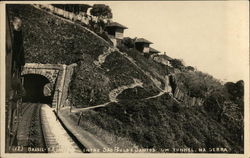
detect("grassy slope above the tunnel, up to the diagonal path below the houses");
top-left (9, 5), bottom-right (158, 107)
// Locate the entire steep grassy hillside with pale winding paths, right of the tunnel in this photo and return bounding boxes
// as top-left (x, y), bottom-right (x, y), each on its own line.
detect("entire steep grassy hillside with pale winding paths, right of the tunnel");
top-left (8, 5), bottom-right (244, 153)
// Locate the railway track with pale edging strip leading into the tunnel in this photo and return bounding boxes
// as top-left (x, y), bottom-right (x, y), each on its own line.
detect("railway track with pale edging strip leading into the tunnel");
top-left (12, 103), bottom-right (82, 153)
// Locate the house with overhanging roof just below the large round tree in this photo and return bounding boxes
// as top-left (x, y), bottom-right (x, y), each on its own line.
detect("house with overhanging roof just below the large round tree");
top-left (106, 22), bottom-right (128, 46)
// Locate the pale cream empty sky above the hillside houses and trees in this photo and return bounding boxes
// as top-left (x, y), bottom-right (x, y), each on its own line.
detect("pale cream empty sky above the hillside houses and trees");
top-left (86, 1), bottom-right (249, 82)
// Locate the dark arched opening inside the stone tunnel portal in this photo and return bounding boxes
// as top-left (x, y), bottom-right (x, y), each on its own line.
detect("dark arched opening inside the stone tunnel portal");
top-left (23, 74), bottom-right (54, 105)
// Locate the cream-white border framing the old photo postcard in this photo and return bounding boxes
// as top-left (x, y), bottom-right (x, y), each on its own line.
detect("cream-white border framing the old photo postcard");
top-left (0, 1), bottom-right (250, 158)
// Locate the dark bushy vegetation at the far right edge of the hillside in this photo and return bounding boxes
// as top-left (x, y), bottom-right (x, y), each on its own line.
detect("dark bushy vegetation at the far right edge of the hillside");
top-left (204, 81), bottom-right (244, 152)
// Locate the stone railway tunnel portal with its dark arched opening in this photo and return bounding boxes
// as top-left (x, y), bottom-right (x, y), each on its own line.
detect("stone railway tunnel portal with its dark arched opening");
top-left (21, 63), bottom-right (76, 108)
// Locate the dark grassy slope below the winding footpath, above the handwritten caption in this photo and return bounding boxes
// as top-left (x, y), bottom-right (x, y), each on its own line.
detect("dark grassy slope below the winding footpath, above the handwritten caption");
top-left (80, 95), bottom-right (242, 152)
